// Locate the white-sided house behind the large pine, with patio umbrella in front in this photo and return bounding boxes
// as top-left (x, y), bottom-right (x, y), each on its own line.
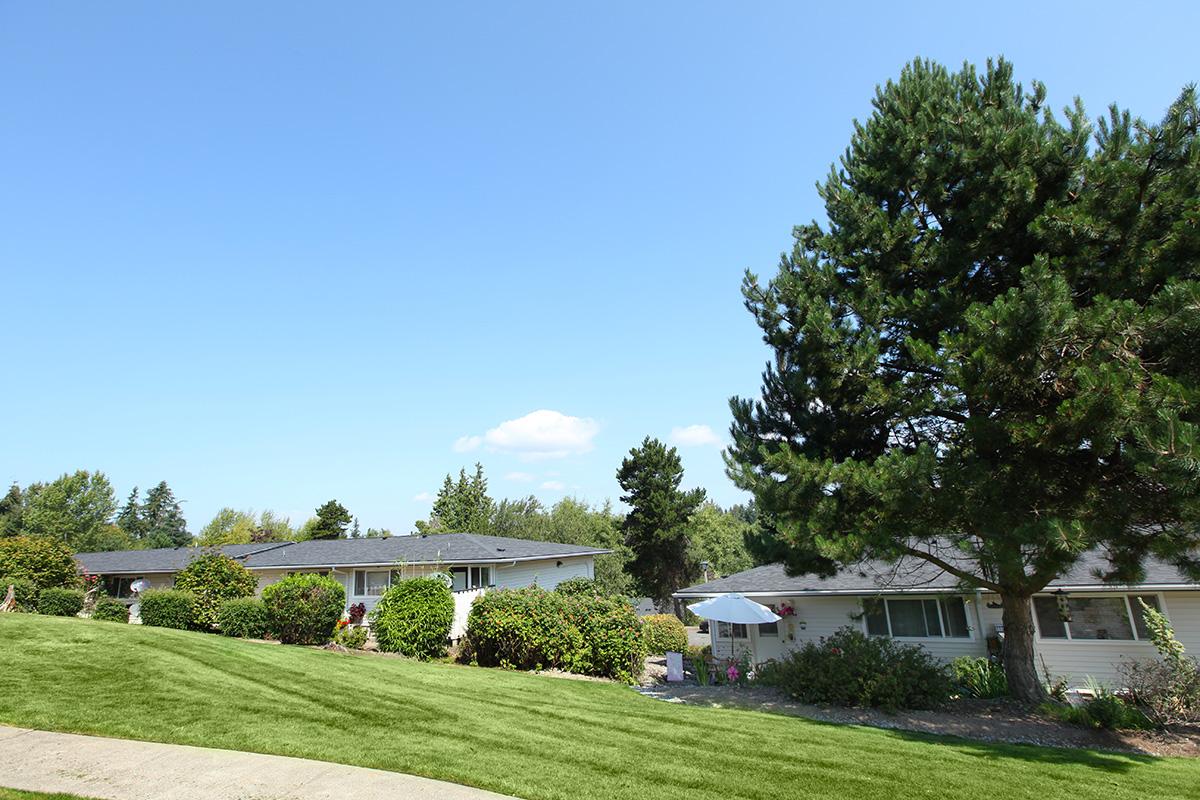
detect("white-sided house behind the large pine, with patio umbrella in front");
top-left (674, 553), bottom-right (1200, 686)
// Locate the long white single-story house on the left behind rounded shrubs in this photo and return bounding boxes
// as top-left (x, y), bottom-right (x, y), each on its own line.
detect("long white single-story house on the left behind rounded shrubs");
top-left (76, 534), bottom-right (610, 639)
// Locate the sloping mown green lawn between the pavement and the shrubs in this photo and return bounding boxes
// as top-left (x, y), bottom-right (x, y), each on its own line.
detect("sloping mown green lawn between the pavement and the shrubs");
top-left (0, 614), bottom-right (1200, 800)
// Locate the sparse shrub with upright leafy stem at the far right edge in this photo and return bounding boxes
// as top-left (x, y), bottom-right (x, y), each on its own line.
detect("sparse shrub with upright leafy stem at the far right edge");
top-left (1120, 599), bottom-right (1200, 726)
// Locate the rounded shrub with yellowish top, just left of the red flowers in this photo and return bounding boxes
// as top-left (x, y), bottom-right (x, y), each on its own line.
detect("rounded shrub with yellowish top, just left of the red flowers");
top-left (263, 572), bottom-right (346, 644)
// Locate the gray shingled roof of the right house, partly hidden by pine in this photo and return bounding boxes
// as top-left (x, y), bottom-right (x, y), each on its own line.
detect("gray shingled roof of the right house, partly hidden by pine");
top-left (676, 551), bottom-right (1200, 597)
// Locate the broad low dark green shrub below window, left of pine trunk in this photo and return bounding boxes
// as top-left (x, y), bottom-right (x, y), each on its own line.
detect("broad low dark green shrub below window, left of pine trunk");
top-left (773, 627), bottom-right (953, 711)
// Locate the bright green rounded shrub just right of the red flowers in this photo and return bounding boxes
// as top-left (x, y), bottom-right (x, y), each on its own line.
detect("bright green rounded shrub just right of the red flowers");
top-left (370, 578), bottom-right (454, 658)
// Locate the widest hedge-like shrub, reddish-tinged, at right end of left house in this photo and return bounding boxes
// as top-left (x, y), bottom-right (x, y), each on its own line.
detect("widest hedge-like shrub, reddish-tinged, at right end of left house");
top-left (462, 587), bottom-right (646, 680)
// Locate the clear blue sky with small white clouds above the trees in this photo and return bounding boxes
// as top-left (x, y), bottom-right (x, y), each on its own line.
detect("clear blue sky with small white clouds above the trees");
top-left (0, 0), bottom-right (1200, 533)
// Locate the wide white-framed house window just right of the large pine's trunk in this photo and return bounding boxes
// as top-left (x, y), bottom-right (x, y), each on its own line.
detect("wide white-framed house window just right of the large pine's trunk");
top-left (1033, 595), bottom-right (1159, 642)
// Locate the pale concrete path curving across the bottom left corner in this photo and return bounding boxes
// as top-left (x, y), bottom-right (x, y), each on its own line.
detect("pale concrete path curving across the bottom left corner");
top-left (0, 726), bottom-right (516, 800)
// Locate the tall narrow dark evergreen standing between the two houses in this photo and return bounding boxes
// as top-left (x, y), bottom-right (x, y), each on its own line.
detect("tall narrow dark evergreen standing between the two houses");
top-left (617, 437), bottom-right (704, 606)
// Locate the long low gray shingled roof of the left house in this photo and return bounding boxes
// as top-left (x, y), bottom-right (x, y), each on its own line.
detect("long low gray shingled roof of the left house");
top-left (76, 534), bottom-right (611, 575)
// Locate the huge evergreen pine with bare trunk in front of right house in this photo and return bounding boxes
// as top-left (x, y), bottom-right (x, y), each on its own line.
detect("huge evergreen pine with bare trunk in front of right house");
top-left (727, 61), bottom-right (1200, 700)
